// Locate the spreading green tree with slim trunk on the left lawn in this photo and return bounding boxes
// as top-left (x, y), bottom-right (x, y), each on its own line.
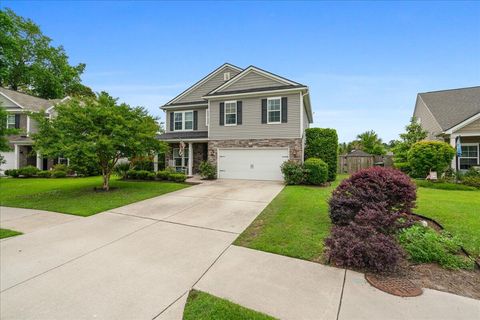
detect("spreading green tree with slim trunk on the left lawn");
top-left (32, 92), bottom-right (167, 190)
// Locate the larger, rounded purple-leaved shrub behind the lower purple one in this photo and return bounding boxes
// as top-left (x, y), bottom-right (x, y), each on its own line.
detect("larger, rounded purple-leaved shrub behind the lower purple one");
top-left (329, 167), bottom-right (416, 226)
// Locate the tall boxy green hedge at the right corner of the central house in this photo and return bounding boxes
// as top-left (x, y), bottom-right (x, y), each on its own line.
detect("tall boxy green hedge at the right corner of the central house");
top-left (305, 128), bottom-right (338, 181)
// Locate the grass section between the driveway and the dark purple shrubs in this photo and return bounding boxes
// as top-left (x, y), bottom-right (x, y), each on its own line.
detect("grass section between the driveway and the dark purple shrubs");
top-left (234, 175), bottom-right (346, 261)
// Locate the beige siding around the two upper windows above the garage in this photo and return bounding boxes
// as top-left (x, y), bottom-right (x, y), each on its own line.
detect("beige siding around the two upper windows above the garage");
top-left (209, 93), bottom-right (301, 140)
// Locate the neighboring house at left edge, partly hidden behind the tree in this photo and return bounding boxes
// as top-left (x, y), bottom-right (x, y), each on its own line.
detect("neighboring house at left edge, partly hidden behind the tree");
top-left (0, 87), bottom-right (66, 171)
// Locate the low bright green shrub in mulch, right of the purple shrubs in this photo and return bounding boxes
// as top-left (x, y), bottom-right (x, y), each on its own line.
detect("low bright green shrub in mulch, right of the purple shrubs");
top-left (398, 225), bottom-right (474, 269)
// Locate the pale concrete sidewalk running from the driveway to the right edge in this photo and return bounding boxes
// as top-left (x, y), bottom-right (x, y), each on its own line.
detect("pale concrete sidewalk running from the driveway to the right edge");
top-left (195, 246), bottom-right (480, 320)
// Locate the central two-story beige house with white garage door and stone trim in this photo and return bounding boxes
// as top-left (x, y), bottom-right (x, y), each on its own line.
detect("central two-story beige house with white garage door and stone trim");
top-left (159, 63), bottom-right (313, 180)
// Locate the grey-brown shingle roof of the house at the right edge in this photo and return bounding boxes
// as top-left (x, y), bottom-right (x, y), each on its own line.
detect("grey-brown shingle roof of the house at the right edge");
top-left (418, 86), bottom-right (480, 131)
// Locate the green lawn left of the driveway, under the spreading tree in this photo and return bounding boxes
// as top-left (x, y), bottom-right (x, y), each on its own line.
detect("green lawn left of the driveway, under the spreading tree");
top-left (0, 177), bottom-right (188, 216)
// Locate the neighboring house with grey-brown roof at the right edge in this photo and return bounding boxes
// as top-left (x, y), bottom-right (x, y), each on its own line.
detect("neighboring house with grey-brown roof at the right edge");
top-left (413, 87), bottom-right (480, 170)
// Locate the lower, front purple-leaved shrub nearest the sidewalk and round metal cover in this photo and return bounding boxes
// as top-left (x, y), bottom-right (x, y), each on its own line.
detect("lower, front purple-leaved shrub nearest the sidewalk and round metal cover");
top-left (325, 223), bottom-right (404, 272)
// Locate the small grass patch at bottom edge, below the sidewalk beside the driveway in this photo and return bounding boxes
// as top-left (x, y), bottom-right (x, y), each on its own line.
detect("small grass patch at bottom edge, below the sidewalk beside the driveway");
top-left (183, 290), bottom-right (275, 320)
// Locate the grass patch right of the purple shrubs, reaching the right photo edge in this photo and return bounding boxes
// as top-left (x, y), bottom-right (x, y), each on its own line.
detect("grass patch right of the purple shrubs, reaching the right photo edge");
top-left (415, 188), bottom-right (480, 257)
